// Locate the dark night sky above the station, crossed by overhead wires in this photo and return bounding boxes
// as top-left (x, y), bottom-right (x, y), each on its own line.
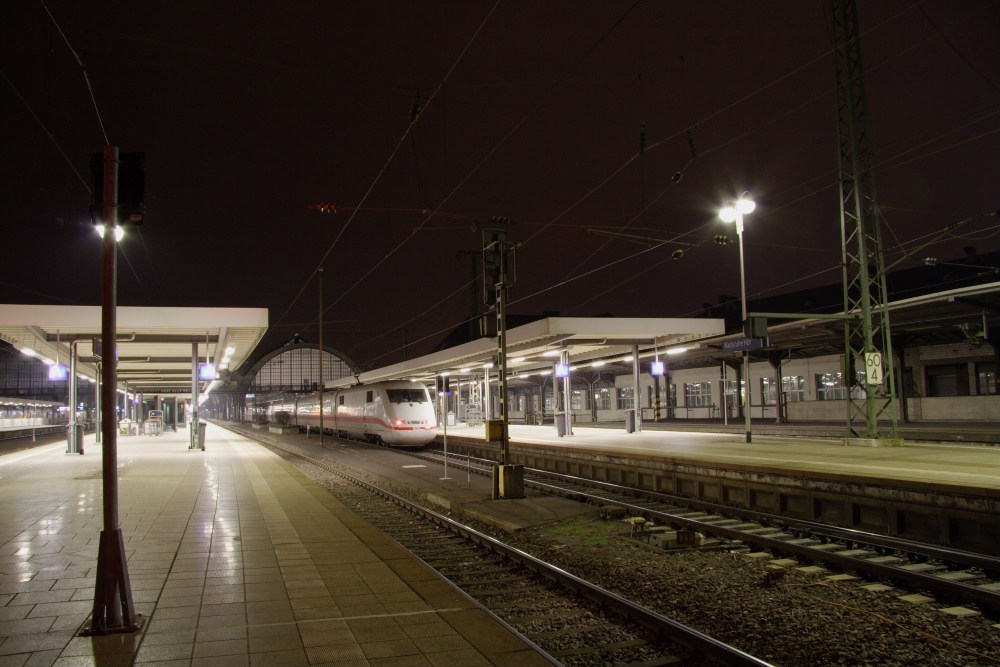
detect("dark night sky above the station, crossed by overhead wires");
top-left (0, 0), bottom-right (1000, 374)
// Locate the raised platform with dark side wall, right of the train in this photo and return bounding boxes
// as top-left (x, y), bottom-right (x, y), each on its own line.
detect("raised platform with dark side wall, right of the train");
top-left (428, 425), bottom-right (1000, 555)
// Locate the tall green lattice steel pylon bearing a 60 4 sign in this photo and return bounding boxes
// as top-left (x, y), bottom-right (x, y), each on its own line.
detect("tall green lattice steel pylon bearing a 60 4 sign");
top-left (831, 0), bottom-right (901, 444)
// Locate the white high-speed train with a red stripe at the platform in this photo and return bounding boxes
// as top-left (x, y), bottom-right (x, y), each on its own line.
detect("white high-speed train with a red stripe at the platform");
top-left (270, 381), bottom-right (437, 448)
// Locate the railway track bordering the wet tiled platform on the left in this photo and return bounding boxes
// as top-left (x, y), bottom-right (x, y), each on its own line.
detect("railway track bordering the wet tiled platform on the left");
top-left (255, 437), bottom-right (769, 667)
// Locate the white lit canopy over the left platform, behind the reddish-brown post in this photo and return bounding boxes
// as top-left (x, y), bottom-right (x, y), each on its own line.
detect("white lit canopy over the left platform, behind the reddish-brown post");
top-left (0, 304), bottom-right (267, 396)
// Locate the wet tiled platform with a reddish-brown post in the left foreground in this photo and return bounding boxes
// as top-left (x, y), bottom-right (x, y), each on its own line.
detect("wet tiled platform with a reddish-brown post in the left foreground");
top-left (0, 425), bottom-right (549, 667)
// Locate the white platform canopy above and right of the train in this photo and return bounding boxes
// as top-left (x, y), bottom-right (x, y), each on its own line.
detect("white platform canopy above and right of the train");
top-left (326, 317), bottom-right (725, 388)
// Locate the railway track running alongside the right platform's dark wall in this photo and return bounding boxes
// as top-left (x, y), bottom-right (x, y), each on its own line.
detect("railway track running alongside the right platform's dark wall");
top-left (416, 451), bottom-right (1000, 613)
